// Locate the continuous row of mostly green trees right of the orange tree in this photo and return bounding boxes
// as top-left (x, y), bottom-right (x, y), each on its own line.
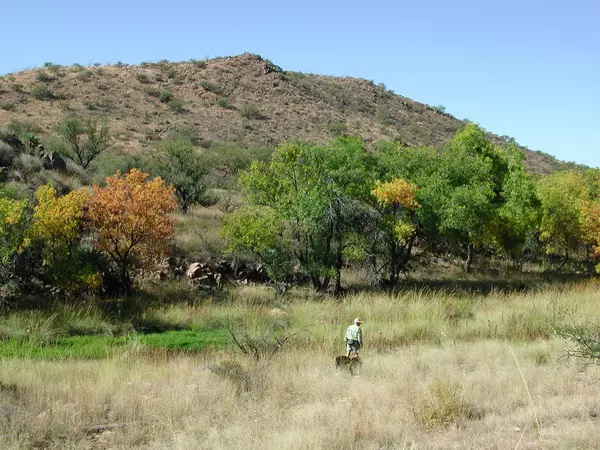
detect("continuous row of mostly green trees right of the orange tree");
top-left (222, 124), bottom-right (600, 293)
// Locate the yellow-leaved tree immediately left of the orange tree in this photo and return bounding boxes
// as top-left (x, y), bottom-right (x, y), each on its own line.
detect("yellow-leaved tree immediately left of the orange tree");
top-left (29, 184), bottom-right (100, 290)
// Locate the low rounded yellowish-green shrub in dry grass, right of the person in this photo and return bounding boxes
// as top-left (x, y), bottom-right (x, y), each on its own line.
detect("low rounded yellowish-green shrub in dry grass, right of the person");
top-left (413, 378), bottom-right (481, 429)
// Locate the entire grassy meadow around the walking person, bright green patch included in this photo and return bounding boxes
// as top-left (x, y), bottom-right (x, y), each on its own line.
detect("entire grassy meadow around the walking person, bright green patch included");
top-left (0, 282), bottom-right (600, 449)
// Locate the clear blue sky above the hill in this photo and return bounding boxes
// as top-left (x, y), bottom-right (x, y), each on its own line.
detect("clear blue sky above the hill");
top-left (0, 0), bottom-right (600, 166)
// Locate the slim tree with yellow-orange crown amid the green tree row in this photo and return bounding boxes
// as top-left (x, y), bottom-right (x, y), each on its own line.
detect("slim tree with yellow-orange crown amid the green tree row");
top-left (371, 178), bottom-right (419, 286)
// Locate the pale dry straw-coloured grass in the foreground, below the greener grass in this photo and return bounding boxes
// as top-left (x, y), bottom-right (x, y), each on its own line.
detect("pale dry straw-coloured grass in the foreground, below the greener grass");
top-left (0, 340), bottom-right (600, 449)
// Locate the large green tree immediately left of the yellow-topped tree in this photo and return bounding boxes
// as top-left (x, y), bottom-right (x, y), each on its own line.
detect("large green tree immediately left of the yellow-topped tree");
top-left (240, 138), bottom-right (375, 292)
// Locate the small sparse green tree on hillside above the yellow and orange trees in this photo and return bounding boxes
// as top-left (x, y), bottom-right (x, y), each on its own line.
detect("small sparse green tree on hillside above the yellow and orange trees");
top-left (59, 117), bottom-right (110, 169)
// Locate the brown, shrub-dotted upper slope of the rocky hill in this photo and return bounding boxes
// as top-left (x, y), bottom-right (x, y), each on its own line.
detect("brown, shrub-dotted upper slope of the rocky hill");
top-left (0, 53), bottom-right (574, 173)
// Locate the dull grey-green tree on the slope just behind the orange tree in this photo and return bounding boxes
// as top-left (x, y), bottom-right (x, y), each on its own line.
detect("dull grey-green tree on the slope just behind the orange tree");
top-left (148, 139), bottom-right (215, 214)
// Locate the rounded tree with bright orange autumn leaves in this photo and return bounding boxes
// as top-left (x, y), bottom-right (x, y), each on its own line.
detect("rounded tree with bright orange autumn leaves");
top-left (88, 169), bottom-right (177, 292)
